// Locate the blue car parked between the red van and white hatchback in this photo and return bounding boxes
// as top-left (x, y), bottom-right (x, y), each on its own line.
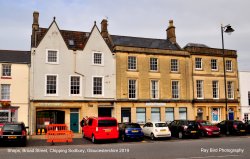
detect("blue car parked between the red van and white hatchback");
top-left (118, 123), bottom-right (144, 141)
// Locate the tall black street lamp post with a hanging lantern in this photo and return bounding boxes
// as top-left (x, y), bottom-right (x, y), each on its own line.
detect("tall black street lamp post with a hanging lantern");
top-left (221, 25), bottom-right (234, 120)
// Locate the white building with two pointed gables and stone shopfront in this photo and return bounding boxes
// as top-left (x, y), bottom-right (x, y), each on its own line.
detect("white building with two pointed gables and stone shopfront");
top-left (30, 12), bottom-right (116, 134)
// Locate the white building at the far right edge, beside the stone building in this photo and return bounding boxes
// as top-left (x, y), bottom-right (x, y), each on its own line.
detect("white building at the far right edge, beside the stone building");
top-left (239, 72), bottom-right (250, 121)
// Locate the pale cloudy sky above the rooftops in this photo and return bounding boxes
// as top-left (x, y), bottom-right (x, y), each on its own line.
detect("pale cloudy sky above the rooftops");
top-left (0, 0), bottom-right (250, 71)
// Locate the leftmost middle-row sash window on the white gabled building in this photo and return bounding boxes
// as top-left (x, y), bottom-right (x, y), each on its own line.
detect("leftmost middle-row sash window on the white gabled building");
top-left (46, 75), bottom-right (57, 94)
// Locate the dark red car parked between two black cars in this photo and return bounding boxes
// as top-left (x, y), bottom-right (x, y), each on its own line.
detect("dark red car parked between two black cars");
top-left (197, 120), bottom-right (220, 136)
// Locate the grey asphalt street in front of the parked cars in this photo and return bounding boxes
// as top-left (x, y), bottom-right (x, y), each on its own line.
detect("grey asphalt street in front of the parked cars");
top-left (0, 136), bottom-right (250, 159)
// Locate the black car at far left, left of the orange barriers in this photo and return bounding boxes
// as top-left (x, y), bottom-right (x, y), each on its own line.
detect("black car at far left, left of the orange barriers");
top-left (0, 122), bottom-right (28, 146)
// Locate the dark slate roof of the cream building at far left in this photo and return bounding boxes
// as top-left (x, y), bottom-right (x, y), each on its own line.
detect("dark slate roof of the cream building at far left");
top-left (0, 50), bottom-right (30, 64)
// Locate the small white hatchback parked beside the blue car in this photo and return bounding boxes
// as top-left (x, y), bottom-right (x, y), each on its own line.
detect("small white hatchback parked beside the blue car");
top-left (142, 122), bottom-right (171, 140)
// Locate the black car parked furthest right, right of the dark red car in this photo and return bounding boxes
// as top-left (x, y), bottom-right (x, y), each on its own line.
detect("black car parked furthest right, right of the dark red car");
top-left (217, 120), bottom-right (246, 135)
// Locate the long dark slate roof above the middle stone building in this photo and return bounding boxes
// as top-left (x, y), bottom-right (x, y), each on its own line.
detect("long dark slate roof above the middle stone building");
top-left (111, 35), bottom-right (181, 50)
